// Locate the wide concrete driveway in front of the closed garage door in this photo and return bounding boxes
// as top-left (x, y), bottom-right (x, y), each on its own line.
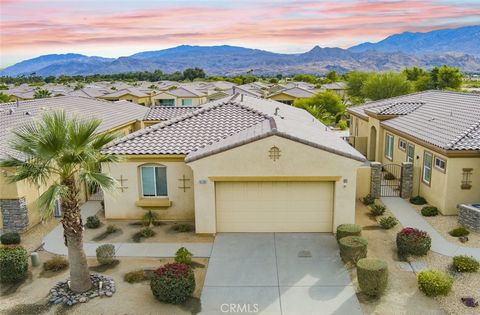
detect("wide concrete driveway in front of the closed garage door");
top-left (201, 233), bottom-right (362, 315)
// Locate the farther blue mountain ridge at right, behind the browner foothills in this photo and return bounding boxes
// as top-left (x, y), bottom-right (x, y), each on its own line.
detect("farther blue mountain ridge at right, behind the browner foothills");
top-left (349, 25), bottom-right (480, 57)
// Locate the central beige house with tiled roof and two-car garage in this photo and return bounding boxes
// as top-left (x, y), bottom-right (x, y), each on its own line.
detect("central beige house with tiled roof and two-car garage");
top-left (103, 94), bottom-right (365, 233)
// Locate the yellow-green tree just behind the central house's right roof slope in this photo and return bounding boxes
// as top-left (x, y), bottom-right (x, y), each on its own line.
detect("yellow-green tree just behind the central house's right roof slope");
top-left (293, 91), bottom-right (345, 125)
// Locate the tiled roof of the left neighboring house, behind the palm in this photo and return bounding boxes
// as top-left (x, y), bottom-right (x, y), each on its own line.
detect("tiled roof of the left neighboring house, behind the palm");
top-left (0, 96), bottom-right (148, 157)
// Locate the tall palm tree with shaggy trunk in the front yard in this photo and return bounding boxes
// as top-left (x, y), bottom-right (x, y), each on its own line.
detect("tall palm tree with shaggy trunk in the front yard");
top-left (0, 111), bottom-right (117, 292)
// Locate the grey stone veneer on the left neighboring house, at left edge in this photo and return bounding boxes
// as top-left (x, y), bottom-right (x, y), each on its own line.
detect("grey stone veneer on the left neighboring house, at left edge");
top-left (0, 197), bottom-right (28, 233)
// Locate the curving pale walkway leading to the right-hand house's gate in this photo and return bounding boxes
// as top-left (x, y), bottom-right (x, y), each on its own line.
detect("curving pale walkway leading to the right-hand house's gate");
top-left (382, 197), bottom-right (480, 260)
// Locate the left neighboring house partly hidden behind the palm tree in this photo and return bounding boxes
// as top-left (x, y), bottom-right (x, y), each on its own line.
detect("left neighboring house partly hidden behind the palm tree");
top-left (0, 96), bottom-right (148, 232)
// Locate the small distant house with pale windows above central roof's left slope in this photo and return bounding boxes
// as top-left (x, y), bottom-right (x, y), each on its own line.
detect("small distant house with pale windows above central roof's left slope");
top-left (152, 87), bottom-right (207, 106)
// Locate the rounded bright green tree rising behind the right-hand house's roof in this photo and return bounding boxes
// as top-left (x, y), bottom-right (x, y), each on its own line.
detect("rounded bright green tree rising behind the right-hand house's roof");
top-left (362, 72), bottom-right (412, 101)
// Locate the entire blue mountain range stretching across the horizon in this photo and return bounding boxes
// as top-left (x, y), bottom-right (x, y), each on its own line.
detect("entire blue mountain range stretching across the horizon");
top-left (0, 26), bottom-right (480, 76)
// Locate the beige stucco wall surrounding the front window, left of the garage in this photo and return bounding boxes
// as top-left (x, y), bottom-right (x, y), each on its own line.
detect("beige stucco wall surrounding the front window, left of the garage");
top-left (102, 158), bottom-right (194, 220)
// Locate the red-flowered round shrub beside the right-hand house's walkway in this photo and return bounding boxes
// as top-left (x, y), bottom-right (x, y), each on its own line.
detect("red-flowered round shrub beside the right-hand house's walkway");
top-left (397, 227), bottom-right (432, 257)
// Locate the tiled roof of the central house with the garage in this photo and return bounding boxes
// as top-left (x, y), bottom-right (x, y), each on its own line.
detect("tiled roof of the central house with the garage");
top-left (104, 94), bottom-right (365, 161)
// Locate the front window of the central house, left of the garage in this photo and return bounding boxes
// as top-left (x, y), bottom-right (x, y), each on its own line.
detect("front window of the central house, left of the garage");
top-left (140, 166), bottom-right (168, 197)
